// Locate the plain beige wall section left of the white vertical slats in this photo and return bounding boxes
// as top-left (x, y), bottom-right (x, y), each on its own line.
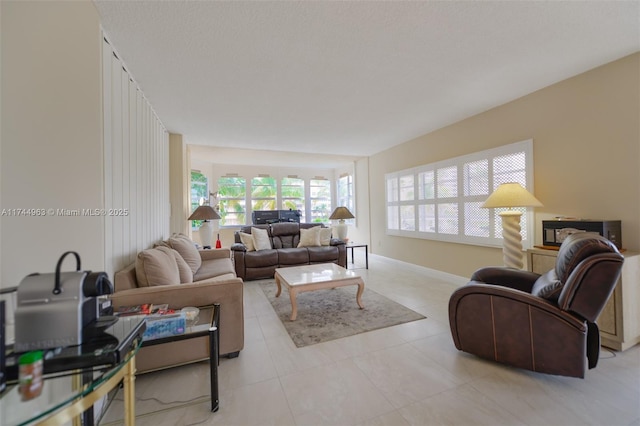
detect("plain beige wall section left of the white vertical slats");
top-left (0, 1), bottom-right (104, 287)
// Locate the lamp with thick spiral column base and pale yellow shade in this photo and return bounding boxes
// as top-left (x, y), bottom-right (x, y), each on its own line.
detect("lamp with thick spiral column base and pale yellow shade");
top-left (482, 182), bottom-right (542, 269)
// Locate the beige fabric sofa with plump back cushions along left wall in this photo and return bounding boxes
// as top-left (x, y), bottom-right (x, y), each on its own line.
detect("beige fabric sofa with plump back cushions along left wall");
top-left (111, 236), bottom-right (244, 372)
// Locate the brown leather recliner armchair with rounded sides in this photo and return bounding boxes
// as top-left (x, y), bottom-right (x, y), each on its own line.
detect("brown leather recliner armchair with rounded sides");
top-left (449, 233), bottom-right (624, 378)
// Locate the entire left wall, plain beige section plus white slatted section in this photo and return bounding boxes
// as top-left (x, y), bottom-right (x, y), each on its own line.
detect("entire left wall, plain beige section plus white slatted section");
top-left (0, 0), bottom-right (169, 287)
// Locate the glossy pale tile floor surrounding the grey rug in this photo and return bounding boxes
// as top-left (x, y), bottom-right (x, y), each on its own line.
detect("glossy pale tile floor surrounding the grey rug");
top-left (101, 255), bottom-right (640, 426)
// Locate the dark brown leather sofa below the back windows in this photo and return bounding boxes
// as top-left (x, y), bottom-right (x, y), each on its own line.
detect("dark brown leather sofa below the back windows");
top-left (231, 222), bottom-right (347, 281)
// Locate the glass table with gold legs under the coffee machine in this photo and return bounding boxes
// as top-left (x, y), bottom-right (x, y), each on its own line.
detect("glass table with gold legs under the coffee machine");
top-left (0, 317), bottom-right (145, 426)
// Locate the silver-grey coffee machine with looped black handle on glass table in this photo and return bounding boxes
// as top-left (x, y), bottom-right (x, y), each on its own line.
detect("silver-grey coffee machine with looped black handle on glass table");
top-left (14, 251), bottom-right (113, 352)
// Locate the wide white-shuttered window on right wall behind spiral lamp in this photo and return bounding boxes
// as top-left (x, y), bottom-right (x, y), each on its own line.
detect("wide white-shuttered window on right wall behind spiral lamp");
top-left (385, 140), bottom-right (533, 247)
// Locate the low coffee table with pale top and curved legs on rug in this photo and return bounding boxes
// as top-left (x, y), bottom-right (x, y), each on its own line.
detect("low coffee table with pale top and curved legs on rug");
top-left (275, 263), bottom-right (364, 321)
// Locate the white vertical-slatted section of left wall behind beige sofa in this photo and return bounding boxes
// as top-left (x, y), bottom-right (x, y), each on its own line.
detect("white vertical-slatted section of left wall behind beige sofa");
top-left (102, 37), bottom-right (171, 276)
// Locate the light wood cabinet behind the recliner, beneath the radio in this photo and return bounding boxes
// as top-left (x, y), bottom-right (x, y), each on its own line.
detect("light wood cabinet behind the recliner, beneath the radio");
top-left (527, 248), bottom-right (640, 351)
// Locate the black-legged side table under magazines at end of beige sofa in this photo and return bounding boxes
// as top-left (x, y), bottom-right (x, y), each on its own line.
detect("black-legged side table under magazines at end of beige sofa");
top-left (142, 304), bottom-right (220, 411)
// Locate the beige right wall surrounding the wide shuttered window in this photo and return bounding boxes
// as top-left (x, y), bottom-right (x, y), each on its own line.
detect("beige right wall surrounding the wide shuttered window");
top-left (369, 53), bottom-right (640, 276)
